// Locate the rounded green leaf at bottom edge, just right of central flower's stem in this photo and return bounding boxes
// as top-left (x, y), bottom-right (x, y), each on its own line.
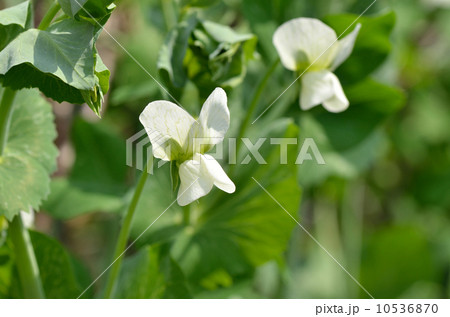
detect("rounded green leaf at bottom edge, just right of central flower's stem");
top-left (115, 247), bottom-right (191, 299)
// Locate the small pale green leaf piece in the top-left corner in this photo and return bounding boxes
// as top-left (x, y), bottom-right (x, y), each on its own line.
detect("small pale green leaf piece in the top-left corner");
top-left (0, 1), bottom-right (33, 51)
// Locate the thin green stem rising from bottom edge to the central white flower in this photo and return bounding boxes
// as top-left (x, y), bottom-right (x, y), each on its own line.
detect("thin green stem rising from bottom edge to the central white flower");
top-left (105, 165), bottom-right (148, 298)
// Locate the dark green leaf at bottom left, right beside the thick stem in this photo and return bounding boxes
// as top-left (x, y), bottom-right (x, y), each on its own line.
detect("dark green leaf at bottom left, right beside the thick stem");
top-left (30, 231), bottom-right (87, 298)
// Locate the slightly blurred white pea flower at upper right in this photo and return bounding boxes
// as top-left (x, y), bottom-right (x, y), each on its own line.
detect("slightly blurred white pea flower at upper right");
top-left (273, 18), bottom-right (361, 112)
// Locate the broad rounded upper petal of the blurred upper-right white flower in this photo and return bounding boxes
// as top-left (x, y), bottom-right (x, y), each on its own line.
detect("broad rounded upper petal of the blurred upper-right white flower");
top-left (273, 18), bottom-right (337, 71)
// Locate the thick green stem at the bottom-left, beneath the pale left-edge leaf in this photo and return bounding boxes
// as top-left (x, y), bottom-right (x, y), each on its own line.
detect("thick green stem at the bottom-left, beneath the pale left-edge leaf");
top-left (9, 214), bottom-right (45, 298)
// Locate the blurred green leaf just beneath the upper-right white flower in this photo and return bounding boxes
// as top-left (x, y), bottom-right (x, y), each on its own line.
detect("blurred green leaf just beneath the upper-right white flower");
top-left (298, 79), bottom-right (405, 186)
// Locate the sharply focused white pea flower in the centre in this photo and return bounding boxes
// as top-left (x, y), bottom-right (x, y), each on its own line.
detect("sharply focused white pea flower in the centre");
top-left (139, 88), bottom-right (236, 206)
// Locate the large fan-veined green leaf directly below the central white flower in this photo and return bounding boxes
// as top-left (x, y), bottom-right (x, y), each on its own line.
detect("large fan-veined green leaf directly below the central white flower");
top-left (172, 176), bottom-right (300, 282)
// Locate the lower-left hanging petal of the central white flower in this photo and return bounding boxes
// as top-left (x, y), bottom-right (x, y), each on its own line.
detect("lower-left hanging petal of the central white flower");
top-left (177, 155), bottom-right (214, 206)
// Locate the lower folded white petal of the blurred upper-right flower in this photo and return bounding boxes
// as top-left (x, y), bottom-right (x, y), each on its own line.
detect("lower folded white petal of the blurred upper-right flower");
top-left (300, 70), bottom-right (349, 112)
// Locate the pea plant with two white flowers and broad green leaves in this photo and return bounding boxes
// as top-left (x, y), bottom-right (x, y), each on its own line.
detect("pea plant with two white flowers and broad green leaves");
top-left (0, 0), bottom-right (404, 298)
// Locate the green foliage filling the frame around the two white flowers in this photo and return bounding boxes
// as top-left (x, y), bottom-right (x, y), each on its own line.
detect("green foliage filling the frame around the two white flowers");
top-left (0, 0), bottom-right (450, 298)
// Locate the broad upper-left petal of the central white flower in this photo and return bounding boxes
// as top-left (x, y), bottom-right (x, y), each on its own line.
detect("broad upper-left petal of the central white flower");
top-left (139, 100), bottom-right (196, 161)
